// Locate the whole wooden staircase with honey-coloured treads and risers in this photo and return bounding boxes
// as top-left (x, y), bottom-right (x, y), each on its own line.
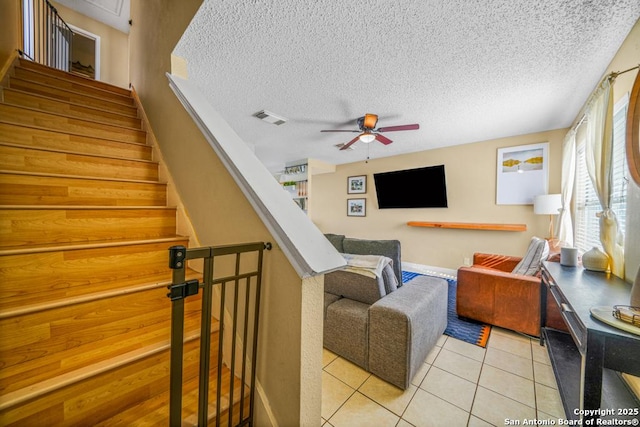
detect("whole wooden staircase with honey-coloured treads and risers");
top-left (0, 59), bottom-right (248, 426)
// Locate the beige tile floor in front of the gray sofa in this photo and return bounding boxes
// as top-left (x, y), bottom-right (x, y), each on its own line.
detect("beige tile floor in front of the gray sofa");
top-left (322, 327), bottom-right (564, 427)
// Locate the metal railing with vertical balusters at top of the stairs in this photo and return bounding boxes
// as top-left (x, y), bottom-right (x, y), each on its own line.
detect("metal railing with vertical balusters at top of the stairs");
top-left (19, 0), bottom-right (74, 71)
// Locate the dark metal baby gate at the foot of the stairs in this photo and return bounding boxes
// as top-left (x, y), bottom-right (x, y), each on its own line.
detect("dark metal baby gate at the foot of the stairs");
top-left (167, 242), bottom-right (271, 426)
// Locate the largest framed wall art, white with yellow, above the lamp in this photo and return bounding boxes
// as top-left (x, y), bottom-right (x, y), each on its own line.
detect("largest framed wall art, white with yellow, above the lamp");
top-left (496, 142), bottom-right (549, 205)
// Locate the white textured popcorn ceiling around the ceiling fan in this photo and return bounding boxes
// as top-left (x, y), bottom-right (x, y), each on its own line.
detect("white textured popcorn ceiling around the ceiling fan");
top-left (174, 0), bottom-right (640, 172)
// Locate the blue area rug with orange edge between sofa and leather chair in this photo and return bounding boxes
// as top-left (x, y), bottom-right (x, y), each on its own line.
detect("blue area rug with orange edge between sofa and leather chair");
top-left (402, 271), bottom-right (491, 347)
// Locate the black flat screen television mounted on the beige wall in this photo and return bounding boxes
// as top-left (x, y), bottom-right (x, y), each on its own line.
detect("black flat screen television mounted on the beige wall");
top-left (373, 165), bottom-right (447, 209)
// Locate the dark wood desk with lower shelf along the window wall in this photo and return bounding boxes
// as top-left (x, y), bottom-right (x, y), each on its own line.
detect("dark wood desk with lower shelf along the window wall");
top-left (540, 262), bottom-right (640, 419)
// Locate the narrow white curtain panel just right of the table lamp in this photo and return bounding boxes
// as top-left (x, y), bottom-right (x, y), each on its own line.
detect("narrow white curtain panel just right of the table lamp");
top-left (558, 129), bottom-right (576, 246)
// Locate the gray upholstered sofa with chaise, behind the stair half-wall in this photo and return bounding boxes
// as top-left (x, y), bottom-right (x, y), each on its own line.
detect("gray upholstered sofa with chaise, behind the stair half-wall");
top-left (323, 234), bottom-right (448, 389)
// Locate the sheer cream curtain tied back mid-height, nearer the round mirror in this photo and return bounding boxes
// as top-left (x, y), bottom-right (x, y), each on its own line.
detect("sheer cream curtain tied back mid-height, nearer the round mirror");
top-left (585, 77), bottom-right (624, 277)
